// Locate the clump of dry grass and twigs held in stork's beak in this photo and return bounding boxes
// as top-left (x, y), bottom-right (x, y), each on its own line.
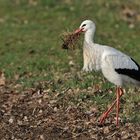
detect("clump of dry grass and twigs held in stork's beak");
top-left (62, 32), bottom-right (80, 49)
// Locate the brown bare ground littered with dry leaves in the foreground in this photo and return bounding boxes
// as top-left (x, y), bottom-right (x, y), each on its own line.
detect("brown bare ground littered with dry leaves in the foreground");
top-left (0, 82), bottom-right (140, 140)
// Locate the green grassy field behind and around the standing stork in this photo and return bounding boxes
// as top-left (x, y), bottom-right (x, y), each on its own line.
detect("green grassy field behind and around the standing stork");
top-left (0, 0), bottom-right (140, 138)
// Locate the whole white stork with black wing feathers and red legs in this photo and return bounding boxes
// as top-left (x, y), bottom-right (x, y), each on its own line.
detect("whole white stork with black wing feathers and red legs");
top-left (75, 20), bottom-right (140, 125)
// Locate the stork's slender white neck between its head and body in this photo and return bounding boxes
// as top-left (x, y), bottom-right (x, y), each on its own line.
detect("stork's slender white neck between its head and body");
top-left (85, 29), bottom-right (95, 44)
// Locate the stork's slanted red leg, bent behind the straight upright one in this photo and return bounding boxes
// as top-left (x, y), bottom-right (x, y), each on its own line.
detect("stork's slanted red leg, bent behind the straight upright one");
top-left (100, 88), bottom-right (123, 124)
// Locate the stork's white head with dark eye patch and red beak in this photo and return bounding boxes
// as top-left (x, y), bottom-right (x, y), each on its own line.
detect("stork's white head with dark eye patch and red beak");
top-left (75, 20), bottom-right (95, 33)
